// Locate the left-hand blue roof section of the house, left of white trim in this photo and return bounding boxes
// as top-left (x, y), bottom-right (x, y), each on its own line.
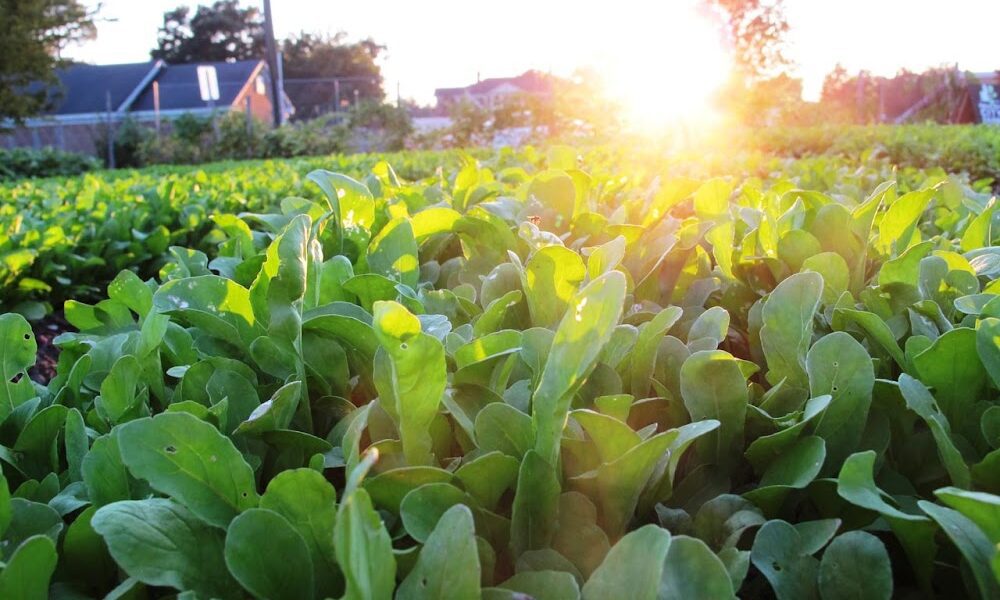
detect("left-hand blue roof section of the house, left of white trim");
top-left (50, 61), bottom-right (162, 115)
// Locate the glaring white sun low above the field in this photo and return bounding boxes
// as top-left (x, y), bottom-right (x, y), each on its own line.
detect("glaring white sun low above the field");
top-left (597, 1), bottom-right (732, 130)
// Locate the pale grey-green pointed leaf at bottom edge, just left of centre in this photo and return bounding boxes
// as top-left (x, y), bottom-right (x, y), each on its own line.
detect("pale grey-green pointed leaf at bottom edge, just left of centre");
top-left (396, 505), bottom-right (480, 600)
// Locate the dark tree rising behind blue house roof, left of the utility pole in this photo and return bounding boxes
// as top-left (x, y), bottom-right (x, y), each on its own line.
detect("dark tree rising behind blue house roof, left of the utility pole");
top-left (150, 0), bottom-right (264, 63)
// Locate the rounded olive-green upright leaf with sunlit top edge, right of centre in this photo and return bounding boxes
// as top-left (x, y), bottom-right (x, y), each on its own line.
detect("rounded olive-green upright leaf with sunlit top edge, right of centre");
top-left (680, 350), bottom-right (749, 465)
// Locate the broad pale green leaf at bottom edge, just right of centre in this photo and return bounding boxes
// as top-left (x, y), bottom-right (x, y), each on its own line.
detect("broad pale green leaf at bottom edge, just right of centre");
top-left (583, 525), bottom-right (671, 600)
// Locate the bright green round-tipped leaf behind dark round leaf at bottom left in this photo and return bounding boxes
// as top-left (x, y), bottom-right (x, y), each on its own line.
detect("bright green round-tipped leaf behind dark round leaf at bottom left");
top-left (260, 469), bottom-right (342, 597)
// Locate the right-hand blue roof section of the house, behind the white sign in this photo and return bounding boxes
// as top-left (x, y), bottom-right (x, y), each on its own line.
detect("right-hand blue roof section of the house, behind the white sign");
top-left (131, 60), bottom-right (264, 111)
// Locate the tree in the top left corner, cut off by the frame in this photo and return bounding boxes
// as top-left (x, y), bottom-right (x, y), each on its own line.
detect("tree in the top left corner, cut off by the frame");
top-left (0, 0), bottom-right (96, 129)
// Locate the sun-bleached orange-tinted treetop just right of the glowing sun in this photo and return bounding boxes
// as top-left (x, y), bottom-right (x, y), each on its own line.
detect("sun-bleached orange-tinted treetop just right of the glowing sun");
top-left (705, 0), bottom-right (788, 81)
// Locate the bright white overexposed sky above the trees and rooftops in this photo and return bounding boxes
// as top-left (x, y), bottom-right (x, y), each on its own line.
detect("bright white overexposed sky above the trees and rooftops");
top-left (65, 0), bottom-right (1000, 103)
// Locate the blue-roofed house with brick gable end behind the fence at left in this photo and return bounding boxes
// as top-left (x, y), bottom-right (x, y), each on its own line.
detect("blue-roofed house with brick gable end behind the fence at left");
top-left (0, 60), bottom-right (292, 154)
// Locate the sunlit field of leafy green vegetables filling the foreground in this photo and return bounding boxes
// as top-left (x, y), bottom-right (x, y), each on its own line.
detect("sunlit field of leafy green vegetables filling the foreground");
top-left (0, 142), bottom-right (1000, 600)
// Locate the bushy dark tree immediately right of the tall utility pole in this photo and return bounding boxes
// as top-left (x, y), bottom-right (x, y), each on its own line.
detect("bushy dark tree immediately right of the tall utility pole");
top-left (282, 32), bottom-right (385, 119)
